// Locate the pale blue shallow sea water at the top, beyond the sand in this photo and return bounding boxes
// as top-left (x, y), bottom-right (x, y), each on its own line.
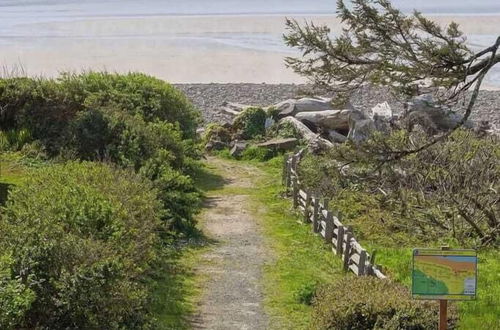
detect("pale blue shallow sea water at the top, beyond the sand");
top-left (0, 0), bottom-right (500, 86)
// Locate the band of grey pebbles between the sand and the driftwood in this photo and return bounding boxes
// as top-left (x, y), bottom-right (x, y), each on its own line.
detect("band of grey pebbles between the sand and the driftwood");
top-left (175, 83), bottom-right (500, 130)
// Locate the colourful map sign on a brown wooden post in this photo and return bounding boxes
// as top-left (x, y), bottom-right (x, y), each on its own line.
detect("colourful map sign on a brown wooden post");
top-left (411, 247), bottom-right (477, 330)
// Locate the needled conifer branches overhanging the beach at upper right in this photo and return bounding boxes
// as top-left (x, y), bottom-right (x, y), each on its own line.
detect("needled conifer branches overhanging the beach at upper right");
top-left (285, 0), bottom-right (500, 104)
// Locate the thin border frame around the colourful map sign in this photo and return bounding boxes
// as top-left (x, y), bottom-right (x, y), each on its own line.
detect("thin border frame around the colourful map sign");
top-left (411, 248), bottom-right (478, 300)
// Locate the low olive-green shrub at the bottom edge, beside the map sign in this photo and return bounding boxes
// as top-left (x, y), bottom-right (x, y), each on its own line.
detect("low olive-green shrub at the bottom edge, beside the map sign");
top-left (312, 277), bottom-right (456, 330)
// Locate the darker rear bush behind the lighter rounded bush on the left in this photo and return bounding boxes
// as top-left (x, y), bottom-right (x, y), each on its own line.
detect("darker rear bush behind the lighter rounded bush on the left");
top-left (0, 72), bottom-right (200, 235)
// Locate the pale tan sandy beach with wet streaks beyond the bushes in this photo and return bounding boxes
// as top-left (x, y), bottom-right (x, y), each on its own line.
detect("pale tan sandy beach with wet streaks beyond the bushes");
top-left (0, 15), bottom-right (500, 87)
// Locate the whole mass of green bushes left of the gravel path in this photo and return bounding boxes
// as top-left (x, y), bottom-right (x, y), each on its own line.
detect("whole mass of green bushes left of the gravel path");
top-left (0, 72), bottom-right (201, 329)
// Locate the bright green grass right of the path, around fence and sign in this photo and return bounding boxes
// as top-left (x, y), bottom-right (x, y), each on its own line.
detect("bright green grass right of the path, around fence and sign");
top-left (235, 155), bottom-right (500, 330)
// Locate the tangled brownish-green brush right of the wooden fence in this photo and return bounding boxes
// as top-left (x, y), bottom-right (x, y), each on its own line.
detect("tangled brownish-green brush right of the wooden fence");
top-left (300, 130), bottom-right (500, 247)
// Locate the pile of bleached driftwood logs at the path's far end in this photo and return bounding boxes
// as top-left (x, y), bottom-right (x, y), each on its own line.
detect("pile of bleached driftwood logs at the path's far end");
top-left (212, 95), bottom-right (471, 155)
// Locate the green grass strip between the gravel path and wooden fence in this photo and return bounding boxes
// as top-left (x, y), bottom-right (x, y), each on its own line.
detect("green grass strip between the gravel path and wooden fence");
top-left (244, 158), bottom-right (345, 329)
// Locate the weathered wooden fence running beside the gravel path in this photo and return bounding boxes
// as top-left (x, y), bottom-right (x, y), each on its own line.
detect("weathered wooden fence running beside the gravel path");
top-left (283, 150), bottom-right (386, 279)
